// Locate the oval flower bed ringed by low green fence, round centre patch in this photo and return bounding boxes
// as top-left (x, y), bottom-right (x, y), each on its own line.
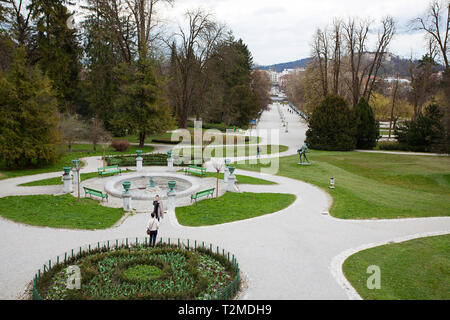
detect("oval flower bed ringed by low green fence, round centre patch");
top-left (33, 242), bottom-right (239, 300)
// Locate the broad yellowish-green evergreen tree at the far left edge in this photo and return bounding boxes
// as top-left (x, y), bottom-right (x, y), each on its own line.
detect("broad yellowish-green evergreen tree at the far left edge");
top-left (0, 47), bottom-right (59, 168)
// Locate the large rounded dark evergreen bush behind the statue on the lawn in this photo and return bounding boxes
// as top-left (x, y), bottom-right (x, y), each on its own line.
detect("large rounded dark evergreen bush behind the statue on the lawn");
top-left (306, 95), bottom-right (356, 151)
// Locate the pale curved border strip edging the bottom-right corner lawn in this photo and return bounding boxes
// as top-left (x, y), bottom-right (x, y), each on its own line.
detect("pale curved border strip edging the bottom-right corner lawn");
top-left (330, 230), bottom-right (450, 300)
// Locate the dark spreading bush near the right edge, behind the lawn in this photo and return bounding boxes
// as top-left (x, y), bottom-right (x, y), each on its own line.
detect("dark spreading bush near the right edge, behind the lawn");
top-left (394, 104), bottom-right (444, 152)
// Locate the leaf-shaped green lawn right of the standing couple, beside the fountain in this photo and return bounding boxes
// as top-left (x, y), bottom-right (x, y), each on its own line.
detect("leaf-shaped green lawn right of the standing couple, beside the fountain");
top-left (176, 192), bottom-right (296, 227)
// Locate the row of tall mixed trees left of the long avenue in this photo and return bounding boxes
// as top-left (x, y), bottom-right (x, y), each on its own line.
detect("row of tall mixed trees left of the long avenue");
top-left (0, 0), bottom-right (270, 167)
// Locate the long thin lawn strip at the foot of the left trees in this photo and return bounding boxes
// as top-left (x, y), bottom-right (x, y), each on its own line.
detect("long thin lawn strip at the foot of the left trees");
top-left (0, 144), bottom-right (155, 179)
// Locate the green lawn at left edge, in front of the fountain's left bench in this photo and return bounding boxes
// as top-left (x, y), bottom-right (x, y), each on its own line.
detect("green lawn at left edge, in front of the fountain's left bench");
top-left (0, 195), bottom-right (123, 230)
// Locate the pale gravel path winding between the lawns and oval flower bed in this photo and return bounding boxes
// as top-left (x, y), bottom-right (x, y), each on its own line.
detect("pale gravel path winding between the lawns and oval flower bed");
top-left (0, 103), bottom-right (450, 299)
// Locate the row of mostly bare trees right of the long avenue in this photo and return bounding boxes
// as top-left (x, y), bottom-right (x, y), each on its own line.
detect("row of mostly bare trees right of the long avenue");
top-left (290, 0), bottom-right (450, 152)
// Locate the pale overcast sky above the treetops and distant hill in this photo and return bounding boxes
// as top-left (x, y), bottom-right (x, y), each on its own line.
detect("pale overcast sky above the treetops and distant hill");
top-left (164, 0), bottom-right (429, 65)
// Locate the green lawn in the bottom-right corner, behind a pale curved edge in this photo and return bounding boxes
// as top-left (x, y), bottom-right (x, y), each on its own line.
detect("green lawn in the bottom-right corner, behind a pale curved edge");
top-left (343, 235), bottom-right (450, 300)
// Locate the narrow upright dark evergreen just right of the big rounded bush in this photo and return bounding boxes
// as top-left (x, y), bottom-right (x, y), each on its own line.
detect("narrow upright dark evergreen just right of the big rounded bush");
top-left (353, 98), bottom-right (380, 149)
